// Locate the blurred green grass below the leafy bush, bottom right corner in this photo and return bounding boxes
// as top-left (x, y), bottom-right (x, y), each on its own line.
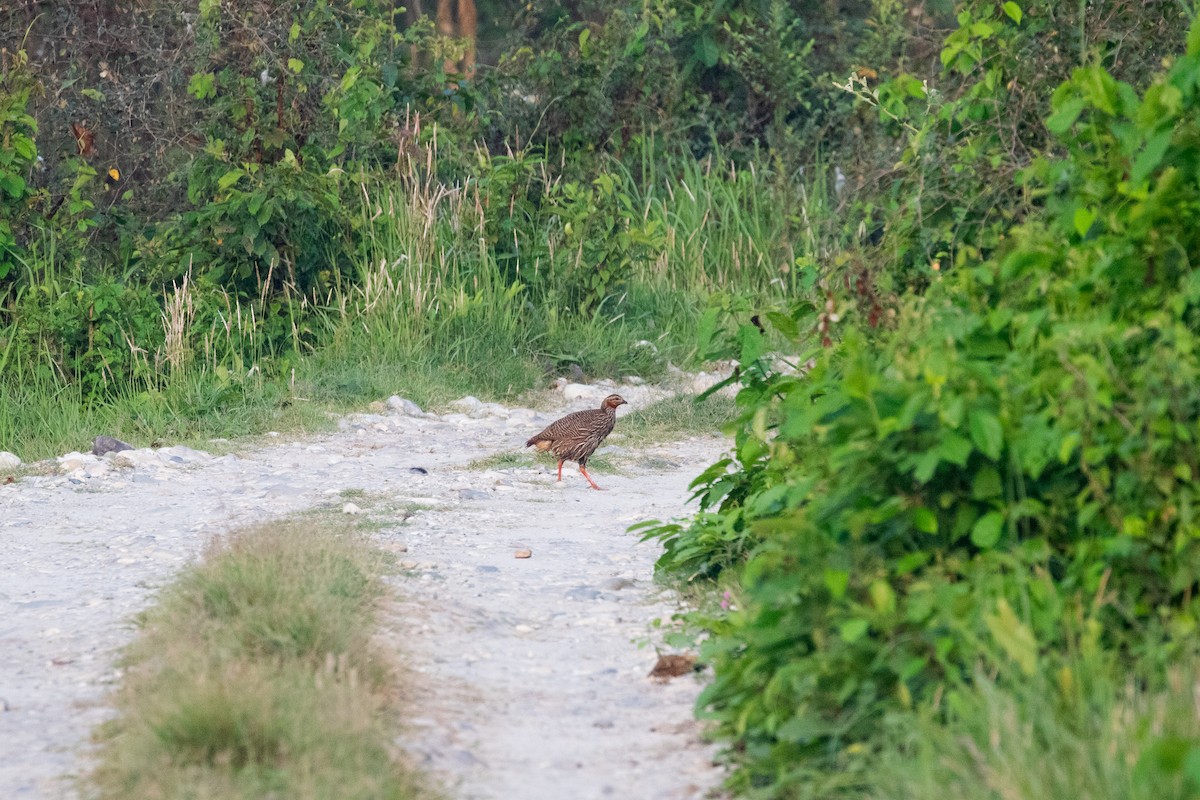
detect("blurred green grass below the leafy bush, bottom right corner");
top-left (865, 662), bottom-right (1200, 800)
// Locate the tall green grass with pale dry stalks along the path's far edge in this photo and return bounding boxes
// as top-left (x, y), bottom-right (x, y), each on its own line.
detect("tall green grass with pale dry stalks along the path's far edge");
top-left (0, 124), bottom-right (832, 461)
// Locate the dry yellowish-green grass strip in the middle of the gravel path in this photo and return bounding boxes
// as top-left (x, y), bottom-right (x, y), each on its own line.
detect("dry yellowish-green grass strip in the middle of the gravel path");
top-left (84, 518), bottom-right (434, 800)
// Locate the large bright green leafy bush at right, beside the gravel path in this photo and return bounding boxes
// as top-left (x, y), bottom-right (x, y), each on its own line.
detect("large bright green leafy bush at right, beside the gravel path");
top-left (652, 13), bottom-right (1200, 796)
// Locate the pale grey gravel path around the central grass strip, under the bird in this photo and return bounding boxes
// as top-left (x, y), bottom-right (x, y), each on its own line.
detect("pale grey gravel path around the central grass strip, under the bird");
top-left (0, 385), bottom-right (724, 800)
